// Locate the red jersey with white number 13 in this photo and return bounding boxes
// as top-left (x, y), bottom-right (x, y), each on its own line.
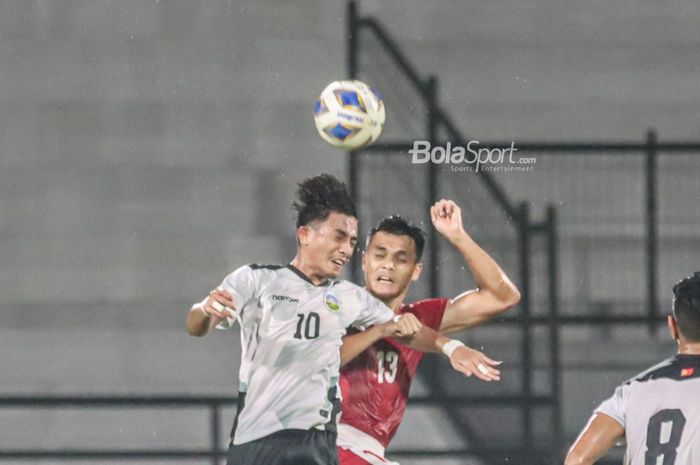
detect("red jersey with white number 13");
top-left (340, 299), bottom-right (448, 447)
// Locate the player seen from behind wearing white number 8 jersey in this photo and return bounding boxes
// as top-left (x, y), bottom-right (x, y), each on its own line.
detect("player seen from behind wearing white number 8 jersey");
top-left (565, 272), bottom-right (700, 465)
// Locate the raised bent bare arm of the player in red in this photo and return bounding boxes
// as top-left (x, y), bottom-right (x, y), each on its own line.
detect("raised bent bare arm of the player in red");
top-left (430, 200), bottom-right (520, 333)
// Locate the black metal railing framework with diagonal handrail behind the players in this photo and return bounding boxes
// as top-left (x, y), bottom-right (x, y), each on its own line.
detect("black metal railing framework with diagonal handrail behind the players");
top-left (347, 1), bottom-right (700, 465)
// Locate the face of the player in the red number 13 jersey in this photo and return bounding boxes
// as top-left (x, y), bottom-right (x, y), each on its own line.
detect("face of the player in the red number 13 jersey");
top-left (362, 231), bottom-right (421, 301)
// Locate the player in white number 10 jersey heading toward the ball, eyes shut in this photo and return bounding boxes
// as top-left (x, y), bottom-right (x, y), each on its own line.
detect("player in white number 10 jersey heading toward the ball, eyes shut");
top-left (187, 174), bottom-right (494, 465)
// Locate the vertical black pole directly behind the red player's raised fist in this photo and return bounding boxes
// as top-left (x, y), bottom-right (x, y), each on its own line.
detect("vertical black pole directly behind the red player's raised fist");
top-left (425, 76), bottom-right (440, 297)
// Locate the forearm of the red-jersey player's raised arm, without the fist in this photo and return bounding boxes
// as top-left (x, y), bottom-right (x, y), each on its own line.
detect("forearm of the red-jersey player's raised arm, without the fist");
top-left (449, 232), bottom-right (520, 308)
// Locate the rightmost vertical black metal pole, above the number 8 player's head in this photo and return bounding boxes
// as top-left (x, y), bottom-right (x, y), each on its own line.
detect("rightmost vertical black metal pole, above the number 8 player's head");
top-left (645, 129), bottom-right (658, 335)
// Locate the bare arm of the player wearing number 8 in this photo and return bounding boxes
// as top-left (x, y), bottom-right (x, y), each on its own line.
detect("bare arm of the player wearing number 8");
top-left (564, 413), bottom-right (625, 465)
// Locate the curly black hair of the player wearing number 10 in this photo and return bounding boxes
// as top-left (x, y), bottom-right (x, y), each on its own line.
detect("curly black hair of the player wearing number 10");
top-left (292, 173), bottom-right (357, 228)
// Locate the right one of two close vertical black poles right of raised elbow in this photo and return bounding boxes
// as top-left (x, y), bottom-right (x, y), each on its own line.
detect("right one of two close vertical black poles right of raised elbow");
top-left (547, 205), bottom-right (562, 463)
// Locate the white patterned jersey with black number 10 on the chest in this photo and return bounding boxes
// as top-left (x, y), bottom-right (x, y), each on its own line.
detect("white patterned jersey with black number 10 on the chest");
top-left (220, 265), bottom-right (394, 445)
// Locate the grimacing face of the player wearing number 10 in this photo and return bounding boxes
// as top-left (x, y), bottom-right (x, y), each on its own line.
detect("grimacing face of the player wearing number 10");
top-left (305, 212), bottom-right (357, 278)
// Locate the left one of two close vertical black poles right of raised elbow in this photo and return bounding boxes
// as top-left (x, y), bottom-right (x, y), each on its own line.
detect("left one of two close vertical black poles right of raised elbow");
top-left (518, 203), bottom-right (533, 464)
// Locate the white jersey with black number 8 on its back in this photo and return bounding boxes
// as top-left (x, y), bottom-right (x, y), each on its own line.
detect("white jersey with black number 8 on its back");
top-left (596, 355), bottom-right (700, 465)
